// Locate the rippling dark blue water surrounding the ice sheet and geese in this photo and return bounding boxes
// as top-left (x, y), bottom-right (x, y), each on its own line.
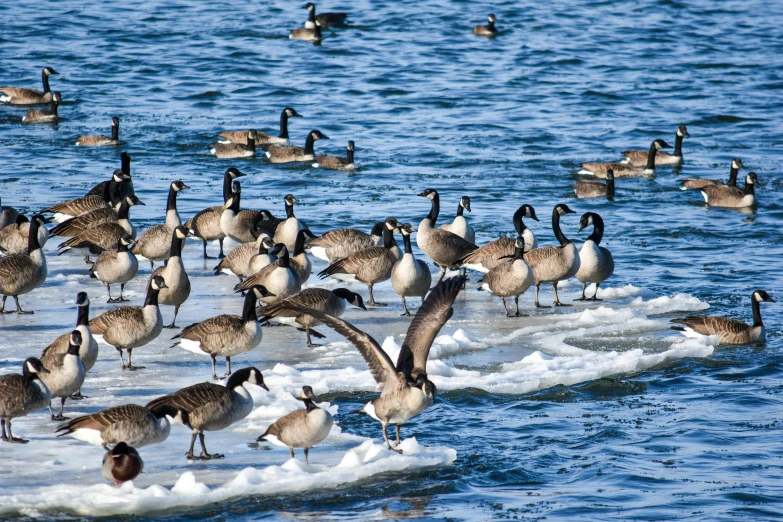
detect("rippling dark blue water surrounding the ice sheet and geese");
top-left (0, 0), bottom-right (783, 520)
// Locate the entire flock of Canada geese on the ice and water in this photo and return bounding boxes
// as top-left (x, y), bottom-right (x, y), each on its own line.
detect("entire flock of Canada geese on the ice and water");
top-left (0, 3), bottom-right (773, 490)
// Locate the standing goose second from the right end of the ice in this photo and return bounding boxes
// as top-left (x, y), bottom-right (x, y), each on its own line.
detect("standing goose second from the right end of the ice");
top-left (524, 203), bottom-right (579, 308)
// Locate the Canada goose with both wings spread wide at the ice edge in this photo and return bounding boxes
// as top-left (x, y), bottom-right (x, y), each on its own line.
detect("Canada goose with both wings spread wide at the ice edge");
top-left (290, 276), bottom-right (466, 453)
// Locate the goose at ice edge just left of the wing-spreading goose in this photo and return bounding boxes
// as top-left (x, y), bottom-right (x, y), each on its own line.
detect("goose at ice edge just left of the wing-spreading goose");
top-left (256, 386), bottom-right (334, 464)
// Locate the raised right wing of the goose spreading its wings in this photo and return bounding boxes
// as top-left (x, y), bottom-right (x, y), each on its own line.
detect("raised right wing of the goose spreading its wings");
top-left (397, 276), bottom-right (467, 379)
